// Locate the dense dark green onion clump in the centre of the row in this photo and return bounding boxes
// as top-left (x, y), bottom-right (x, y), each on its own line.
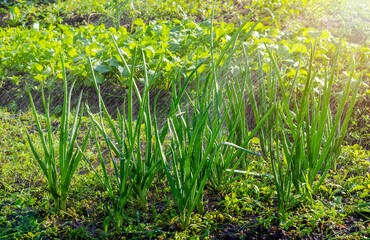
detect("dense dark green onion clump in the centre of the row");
top-left (155, 9), bottom-right (268, 229)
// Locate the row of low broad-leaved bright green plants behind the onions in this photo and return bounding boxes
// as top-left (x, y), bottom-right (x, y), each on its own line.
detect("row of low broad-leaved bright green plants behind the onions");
top-left (0, 18), bottom-right (370, 88)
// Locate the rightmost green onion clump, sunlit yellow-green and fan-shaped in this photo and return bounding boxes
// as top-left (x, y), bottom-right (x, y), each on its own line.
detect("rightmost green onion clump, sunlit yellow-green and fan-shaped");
top-left (270, 40), bottom-right (360, 219)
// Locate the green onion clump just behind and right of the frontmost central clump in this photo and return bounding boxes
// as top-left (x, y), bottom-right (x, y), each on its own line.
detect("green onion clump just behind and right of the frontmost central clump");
top-left (205, 10), bottom-right (275, 191)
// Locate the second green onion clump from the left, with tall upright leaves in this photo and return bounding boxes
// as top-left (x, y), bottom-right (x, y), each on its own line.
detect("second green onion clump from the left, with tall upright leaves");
top-left (84, 39), bottom-right (161, 229)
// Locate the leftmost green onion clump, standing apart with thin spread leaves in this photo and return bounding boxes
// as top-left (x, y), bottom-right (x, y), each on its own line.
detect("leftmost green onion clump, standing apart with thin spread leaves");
top-left (27, 57), bottom-right (90, 211)
